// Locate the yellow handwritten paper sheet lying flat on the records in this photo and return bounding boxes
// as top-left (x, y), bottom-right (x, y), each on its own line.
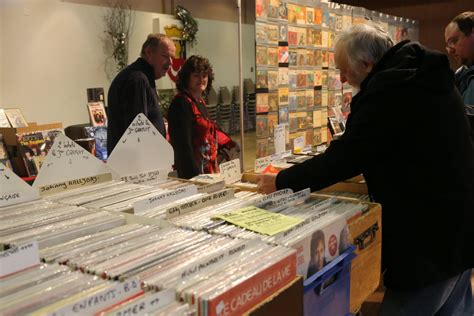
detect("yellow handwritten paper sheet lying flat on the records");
top-left (215, 206), bottom-right (302, 236)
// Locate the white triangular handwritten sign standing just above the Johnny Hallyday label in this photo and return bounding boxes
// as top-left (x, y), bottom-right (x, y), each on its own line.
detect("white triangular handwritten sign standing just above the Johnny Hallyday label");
top-left (33, 134), bottom-right (118, 189)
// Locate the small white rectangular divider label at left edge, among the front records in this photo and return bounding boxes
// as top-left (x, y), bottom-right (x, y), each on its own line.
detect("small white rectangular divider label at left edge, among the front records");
top-left (0, 241), bottom-right (40, 278)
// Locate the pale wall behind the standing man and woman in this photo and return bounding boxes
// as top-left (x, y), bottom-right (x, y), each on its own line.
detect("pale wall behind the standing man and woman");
top-left (0, 0), bottom-right (255, 126)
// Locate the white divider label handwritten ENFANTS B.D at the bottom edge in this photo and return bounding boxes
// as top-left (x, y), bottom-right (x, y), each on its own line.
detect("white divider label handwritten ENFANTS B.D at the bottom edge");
top-left (49, 279), bottom-right (143, 316)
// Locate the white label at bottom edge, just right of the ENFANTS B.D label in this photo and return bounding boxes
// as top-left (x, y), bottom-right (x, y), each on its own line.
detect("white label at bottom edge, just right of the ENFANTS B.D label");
top-left (105, 289), bottom-right (176, 316)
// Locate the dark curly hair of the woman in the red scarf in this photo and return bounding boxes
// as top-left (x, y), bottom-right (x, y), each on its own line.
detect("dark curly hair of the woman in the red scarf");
top-left (176, 55), bottom-right (214, 94)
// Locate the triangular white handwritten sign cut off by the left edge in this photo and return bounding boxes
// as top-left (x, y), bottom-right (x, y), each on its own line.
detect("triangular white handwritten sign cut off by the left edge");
top-left (0, 163), bottom-right (39, 207)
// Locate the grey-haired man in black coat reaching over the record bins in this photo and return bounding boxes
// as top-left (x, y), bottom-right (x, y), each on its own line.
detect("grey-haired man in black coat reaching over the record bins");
top-left (258, 25), bottom-right (474, 315)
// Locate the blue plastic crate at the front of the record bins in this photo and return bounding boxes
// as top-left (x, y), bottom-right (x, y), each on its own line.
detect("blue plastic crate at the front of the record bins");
top-left (303, 246), bottom-right (356, 316)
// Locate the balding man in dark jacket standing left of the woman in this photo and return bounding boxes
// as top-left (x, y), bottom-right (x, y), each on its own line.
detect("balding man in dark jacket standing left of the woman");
top-left (107, 34), bottom-right (176, 155)
